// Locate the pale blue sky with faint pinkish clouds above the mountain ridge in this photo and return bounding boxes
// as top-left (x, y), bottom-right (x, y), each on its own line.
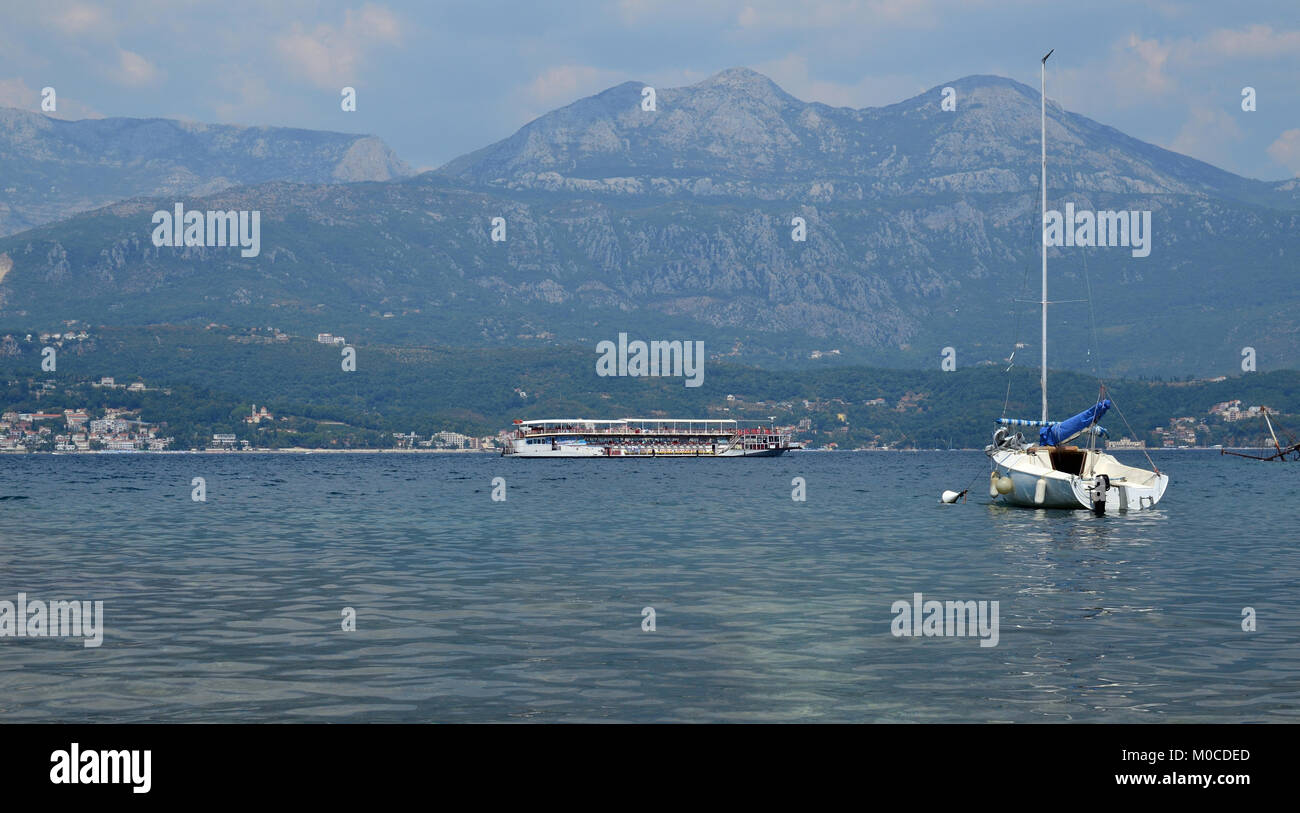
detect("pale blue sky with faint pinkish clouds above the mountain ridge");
top-left (0, 0), bottom-right (1300, 181)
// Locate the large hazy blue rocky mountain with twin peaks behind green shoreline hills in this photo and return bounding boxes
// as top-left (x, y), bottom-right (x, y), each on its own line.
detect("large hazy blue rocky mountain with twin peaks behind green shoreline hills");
top-left (0, 69), bottom-right (1300, 376)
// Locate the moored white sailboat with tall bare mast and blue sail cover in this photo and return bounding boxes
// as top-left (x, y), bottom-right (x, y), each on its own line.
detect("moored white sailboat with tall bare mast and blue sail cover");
top-left (984, 48), bottom-right (1169, 514)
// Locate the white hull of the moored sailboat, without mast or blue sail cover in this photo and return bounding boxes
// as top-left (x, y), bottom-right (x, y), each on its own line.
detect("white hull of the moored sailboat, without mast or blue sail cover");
top-left (989, 447), bottom-right (1169, 511)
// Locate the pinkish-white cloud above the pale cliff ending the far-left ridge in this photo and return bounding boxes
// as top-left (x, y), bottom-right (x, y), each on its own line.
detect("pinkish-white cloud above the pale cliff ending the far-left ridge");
top-left (276, 4), bottom-right (402, 90)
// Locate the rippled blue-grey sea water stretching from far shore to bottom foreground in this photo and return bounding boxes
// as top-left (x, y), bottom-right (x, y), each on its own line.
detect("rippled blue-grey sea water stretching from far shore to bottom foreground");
top-left (0, 451), bottom-right (1300, 722)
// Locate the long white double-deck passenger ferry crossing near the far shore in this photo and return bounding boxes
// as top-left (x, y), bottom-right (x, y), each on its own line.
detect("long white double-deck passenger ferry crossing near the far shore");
top-left (502, 418), bottom-right (800, 458)
